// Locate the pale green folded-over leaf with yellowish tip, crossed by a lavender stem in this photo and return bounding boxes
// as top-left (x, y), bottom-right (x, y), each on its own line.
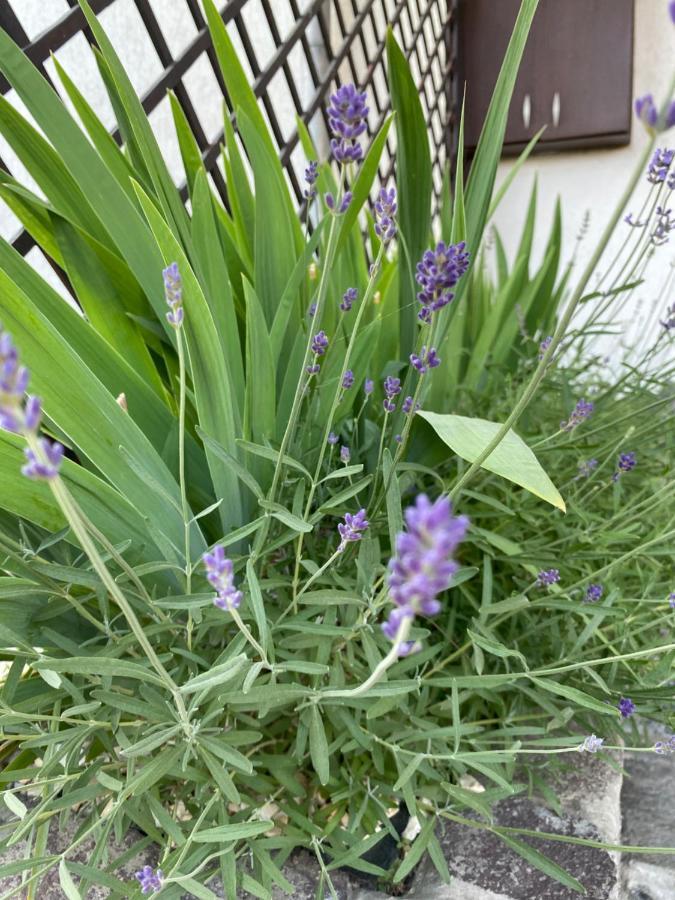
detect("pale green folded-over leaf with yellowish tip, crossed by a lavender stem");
top-left (418, 410), bottom-right (566, 512)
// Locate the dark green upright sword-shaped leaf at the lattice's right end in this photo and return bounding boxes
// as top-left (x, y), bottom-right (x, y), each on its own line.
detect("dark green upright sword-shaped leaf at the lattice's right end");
top-left (387, 28), bottom-right (432, 359)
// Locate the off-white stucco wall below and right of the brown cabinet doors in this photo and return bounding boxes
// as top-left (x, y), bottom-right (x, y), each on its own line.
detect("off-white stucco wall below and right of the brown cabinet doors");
top-left (494, 0), bottom-right (675, 352)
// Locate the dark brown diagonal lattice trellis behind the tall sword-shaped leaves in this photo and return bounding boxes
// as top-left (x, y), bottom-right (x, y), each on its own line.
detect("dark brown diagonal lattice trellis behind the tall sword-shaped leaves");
top-left (0, 0), bottom-right (456, 262)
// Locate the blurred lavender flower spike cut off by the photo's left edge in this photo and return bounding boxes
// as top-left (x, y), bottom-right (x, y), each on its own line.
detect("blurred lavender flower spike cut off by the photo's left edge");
top-left (0, 326), bottom-right (63, 481)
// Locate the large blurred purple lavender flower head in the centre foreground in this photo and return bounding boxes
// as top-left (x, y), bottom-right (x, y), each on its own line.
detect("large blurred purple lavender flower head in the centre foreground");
top-left (382, 494), bottom-right (469, 640)
